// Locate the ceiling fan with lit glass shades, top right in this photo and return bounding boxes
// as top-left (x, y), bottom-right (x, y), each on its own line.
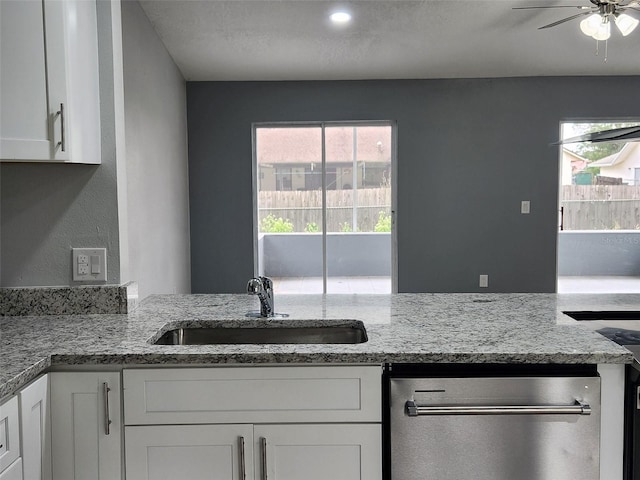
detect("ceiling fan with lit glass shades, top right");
top-left (513, 0), bottom-right (640, 41)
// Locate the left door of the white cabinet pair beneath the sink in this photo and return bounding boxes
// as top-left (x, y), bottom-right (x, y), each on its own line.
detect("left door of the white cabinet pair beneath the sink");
top-left (125, 425), bottom-right (254, 480)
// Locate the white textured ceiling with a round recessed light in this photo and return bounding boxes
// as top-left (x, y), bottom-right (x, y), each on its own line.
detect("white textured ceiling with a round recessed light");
top-left (140, 0), bottom-right (640, 80)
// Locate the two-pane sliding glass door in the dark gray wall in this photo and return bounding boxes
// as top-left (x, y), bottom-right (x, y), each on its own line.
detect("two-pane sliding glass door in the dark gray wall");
top-left (254, 122), bottom-right (395, 293)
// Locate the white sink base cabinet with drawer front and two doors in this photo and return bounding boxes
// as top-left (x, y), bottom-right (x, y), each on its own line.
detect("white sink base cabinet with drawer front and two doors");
top-left (124, 366), bottom-right (382, 480)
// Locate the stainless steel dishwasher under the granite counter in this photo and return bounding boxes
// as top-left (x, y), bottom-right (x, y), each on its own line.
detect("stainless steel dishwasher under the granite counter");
top-left (385, 369), bottom-right (600, 480)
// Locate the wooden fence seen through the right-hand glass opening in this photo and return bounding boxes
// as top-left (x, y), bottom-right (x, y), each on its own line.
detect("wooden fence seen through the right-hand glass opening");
top-left (561, 185), bottom-right (640, 230)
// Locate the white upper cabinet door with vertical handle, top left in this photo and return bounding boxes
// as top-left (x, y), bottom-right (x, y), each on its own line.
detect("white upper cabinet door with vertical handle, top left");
top-left (0, 0), bottom-right (68, 161)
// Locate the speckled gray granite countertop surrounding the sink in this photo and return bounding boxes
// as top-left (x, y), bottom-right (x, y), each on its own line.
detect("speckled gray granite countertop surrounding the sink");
top-left (0, 294), bottom-right (640, 398)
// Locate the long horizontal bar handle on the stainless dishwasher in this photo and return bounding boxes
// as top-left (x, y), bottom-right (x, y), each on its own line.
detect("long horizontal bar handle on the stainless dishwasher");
top-left (405, 400), bottom-right (591, 417)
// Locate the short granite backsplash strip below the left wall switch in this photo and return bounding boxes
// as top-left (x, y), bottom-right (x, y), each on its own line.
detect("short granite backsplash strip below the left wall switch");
top-left (0, 282), bottom-right (138, 316)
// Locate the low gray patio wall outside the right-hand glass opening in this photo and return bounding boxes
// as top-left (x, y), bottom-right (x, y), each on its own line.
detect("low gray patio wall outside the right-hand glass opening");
top-left (558, 230), bottom-right (640, 276)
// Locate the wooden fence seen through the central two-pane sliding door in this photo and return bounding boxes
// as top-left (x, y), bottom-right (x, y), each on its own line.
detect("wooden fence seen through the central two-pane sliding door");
top-left (258, 187), bottom-right (391, 232)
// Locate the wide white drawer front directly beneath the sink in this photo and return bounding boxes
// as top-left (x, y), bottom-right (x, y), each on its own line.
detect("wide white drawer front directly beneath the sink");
top-left (124, 366), bottom-right (381, 425)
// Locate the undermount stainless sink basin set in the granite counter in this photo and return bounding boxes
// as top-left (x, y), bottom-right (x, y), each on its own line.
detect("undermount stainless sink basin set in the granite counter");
top-left (154, 320), bottom-right (368, 345)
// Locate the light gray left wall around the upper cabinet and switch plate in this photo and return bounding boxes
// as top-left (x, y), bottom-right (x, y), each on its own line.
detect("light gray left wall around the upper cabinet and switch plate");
top-left (0, 1), bottom-right (190, 298)
